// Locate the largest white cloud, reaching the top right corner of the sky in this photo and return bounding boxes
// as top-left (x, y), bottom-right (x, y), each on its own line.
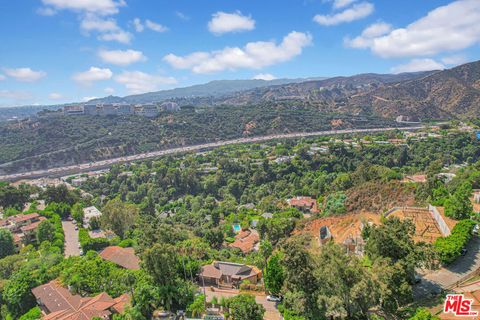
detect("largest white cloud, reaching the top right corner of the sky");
top-left (348, 0), bottom-right (480, 58)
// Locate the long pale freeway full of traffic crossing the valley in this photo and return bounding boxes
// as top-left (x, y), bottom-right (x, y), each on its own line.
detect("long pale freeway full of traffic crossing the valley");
top-left (0, 125), bottom-right (425, 181)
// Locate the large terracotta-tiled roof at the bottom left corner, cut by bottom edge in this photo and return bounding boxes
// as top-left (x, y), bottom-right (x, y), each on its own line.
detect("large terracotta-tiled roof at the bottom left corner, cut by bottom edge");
top-left (32, 280), bottom-right (130, 320)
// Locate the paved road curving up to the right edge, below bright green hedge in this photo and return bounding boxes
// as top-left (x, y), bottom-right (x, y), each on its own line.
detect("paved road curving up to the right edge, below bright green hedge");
top-left (414, 237), bottom-right (480, 298)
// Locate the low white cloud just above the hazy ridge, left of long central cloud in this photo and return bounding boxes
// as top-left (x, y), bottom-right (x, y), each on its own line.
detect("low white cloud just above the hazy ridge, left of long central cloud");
top-left (115, 71), bottom-right (177, 94)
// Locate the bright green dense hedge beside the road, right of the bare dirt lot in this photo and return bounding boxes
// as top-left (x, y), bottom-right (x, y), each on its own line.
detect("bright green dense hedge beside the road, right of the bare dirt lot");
top-left (434, 219), bottom-right (475, 264)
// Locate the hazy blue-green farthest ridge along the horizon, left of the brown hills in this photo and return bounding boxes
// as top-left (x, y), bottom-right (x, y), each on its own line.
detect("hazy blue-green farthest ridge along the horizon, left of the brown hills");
top-left (89, 78), bottom-right (325, 103)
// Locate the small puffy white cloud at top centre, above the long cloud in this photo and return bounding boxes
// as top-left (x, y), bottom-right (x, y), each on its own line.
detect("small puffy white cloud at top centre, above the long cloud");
top-left (208, 11), bottom-right (255, 35)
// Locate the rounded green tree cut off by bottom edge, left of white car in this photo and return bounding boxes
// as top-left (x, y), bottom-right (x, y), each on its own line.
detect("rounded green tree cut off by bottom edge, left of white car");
top-left (227, 294), bottom-right (265, 320)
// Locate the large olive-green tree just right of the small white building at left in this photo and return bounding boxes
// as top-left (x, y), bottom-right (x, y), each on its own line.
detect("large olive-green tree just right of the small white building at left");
top-left (100, 198), bottom-right (139, 239)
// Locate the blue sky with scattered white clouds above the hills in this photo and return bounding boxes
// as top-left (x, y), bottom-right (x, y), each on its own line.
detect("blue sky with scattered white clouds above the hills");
top-left (0, 0), bottom-right (480, 106)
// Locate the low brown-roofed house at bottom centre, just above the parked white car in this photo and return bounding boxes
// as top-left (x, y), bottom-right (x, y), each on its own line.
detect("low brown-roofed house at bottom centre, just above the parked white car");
top-left (199, 261), bottom-right (262, 287)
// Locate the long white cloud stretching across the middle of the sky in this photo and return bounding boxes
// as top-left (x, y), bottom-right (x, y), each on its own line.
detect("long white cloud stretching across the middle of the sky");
top-left (163, 31), bottom-right (312, 73)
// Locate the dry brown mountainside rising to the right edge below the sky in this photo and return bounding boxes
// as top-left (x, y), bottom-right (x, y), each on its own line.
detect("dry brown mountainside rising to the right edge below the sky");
top-left (348, 61), bottom-right (480, 119)
